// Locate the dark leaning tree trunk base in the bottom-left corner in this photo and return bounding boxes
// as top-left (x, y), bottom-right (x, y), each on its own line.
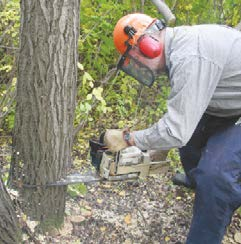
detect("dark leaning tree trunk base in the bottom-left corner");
top-left (0, 178), bottom-right (21, 244)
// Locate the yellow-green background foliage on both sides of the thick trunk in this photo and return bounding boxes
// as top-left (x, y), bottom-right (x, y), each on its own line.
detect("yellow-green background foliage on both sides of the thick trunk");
top-left (0, 0), bottom-right (241, 138)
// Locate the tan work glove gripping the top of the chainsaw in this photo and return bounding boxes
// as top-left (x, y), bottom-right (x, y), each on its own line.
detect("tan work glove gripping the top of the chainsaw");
top-left (104, 129), bottom-right (130, 152)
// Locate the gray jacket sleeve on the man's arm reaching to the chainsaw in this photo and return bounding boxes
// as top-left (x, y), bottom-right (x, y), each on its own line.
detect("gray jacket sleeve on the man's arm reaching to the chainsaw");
top-left (134, 56), bottom-right (222, 150)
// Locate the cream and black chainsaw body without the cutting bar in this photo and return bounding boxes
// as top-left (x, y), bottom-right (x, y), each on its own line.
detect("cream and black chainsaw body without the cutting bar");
top-left (90, 138), bottom-right (168, 181)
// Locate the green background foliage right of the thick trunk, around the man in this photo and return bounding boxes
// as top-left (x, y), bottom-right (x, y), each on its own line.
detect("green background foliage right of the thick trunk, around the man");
top-left (75, 0), bottom-right (241, 137)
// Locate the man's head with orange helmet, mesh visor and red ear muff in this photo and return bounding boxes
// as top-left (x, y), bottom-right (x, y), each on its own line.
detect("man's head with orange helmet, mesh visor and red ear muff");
top-left (113, 13), bottom-right (165, 86)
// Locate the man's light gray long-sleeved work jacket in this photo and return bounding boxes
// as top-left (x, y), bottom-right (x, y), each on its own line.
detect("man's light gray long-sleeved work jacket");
top-left (134, 25), bottom-right (241, 150)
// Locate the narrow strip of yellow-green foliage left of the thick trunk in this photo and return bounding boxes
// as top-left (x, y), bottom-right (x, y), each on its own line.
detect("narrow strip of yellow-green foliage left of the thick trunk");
top-left (0, 0), bottom-right (20, 131)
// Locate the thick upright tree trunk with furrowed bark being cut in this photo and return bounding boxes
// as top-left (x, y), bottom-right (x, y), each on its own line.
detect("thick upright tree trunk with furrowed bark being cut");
top-left (10, 0), bottom-right (80, 231)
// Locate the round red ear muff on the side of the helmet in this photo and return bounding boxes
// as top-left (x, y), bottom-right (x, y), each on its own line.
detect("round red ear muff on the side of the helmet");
top-left (138, 35), bottom-right (163, 58)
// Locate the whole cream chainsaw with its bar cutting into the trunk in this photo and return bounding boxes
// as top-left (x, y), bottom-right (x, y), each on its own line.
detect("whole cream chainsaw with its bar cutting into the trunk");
top-left (49, 135), bottom-right (169, 186)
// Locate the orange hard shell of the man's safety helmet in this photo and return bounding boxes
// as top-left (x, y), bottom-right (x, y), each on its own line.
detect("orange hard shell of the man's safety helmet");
top-left (113, 13), bottom-right (156, 54)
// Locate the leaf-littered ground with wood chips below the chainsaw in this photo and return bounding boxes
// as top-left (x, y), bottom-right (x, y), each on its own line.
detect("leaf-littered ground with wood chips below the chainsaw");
top-left (41, 171), bottom-right (241, 244)
